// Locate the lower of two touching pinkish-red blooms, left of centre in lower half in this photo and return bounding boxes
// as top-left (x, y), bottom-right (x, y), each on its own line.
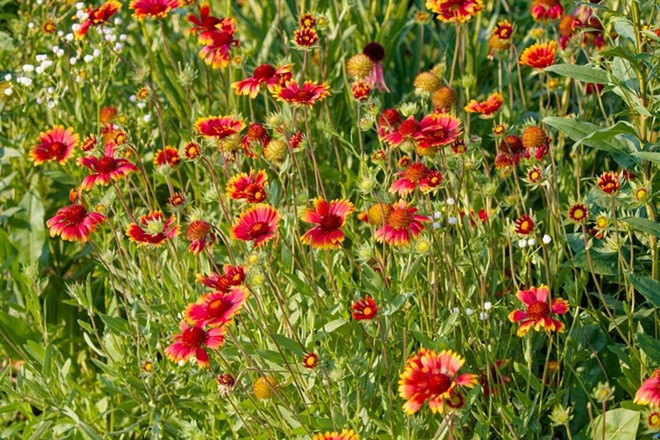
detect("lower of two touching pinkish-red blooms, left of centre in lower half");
top-left (165, 321), bottom-right (226, 367)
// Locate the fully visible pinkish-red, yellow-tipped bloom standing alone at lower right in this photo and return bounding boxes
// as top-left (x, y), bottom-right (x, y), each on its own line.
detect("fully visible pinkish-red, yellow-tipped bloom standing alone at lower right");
top-left (509, 286), bottom-right (568, 336)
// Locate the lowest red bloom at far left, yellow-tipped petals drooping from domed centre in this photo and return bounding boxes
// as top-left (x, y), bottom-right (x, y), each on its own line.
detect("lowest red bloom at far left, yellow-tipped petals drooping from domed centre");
top-left (46, 203), bottom-right (106, 243)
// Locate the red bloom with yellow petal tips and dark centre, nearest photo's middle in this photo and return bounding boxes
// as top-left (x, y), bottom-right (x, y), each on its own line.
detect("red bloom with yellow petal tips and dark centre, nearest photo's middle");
top-left (301, 197), bottom-right (354, 249)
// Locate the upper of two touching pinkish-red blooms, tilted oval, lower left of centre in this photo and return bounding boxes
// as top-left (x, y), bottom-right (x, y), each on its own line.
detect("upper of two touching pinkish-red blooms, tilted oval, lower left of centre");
top-left (186, 286), bottom-right (248, 327)
